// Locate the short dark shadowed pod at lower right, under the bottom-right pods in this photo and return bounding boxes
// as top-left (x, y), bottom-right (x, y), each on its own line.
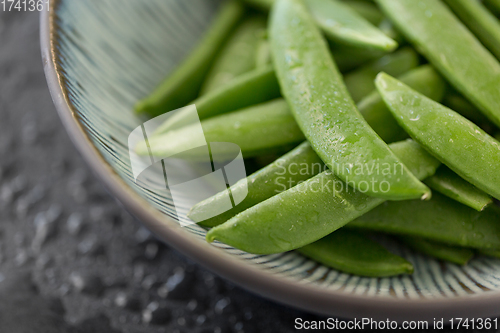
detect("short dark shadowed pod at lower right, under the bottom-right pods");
top-left (399, 236), bottom-right (474, 266)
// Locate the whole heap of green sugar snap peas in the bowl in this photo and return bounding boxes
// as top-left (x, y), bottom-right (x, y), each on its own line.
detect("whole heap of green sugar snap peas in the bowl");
top-left (135, 0), bottom-right (500, 277)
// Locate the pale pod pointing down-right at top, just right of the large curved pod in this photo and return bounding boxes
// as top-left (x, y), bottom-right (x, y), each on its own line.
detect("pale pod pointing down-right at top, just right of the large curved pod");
top-left (246, 0), bottom-right (398, 52)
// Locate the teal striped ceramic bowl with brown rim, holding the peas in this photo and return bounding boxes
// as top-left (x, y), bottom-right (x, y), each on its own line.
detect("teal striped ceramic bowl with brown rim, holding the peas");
top-left (41, 0), bottom-right (500, 321)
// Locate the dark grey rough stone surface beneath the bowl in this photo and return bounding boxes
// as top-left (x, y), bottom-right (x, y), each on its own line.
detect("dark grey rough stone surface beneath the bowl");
top-left (0, 9), bottom-right (498, 333)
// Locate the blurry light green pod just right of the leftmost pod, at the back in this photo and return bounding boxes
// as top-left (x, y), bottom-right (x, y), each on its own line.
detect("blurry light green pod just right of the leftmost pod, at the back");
top-left (200, 15), bottom-right (267, 95)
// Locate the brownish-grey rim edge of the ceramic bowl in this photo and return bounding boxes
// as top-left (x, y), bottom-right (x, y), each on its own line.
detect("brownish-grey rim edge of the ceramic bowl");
top-left (40, 0), bottom-right (500, 322)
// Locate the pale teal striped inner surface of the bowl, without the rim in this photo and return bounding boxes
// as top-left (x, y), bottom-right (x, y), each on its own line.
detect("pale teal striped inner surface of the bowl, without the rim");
top-left (49, 0), bottom-right (500, 299)
